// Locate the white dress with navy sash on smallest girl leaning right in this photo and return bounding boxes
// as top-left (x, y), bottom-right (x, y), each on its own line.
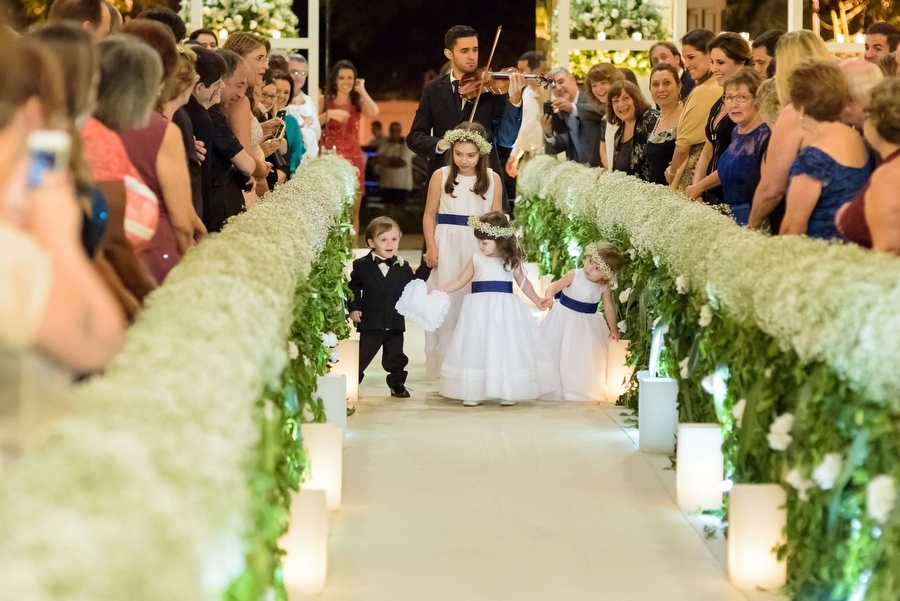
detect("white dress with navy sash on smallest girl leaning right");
top-left (541, 269), bottom-right (609, 401)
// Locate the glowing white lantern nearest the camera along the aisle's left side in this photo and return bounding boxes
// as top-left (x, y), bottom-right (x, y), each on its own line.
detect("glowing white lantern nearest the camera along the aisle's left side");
top-left (279, 490), bottom-right (328, 601)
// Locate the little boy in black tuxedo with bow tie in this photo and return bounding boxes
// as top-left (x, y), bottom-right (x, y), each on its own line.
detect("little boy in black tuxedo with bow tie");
top-left (350, 217), bottom-right (431, 398)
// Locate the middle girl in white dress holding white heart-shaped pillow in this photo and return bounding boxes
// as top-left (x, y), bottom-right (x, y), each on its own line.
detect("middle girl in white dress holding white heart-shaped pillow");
top-left (438, 212), bottom-right (559, 407)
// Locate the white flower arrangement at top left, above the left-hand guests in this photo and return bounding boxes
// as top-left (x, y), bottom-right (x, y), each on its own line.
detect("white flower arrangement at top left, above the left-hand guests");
top-left (181, 0), bottom-right (300, 38)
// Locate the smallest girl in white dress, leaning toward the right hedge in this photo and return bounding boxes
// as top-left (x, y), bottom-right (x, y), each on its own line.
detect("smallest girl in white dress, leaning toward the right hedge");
top-left (541, 242), bottom-right (622, 401)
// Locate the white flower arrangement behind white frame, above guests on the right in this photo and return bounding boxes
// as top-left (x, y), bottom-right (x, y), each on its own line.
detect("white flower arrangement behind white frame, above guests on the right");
top-left (551, 0), bottom-right (671, 78)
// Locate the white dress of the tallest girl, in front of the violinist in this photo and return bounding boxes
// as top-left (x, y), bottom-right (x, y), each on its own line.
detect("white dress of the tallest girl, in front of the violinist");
top-left (425, 167), bottom-right (494, 379)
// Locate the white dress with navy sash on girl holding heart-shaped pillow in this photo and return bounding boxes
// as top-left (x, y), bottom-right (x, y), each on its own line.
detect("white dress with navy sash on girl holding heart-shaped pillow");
top-left (440, 252), bottom-right (559, 401)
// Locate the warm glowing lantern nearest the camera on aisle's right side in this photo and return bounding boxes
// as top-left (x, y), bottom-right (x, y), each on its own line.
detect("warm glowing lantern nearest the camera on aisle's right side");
top-left (728, 484), bottom-right (787, 590)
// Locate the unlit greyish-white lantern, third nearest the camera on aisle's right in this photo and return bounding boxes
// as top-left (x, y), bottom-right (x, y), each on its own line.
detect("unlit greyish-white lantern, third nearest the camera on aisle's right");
top-left (638, 377), bottom-right (678, 453)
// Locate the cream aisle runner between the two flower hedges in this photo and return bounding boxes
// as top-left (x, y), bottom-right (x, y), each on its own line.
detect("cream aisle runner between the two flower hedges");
top-left (318, 322), bottom-right (757, 601)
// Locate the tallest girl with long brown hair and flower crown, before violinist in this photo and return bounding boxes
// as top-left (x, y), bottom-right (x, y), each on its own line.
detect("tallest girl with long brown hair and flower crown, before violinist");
top-left (422, 123), bottom-right (502, 379)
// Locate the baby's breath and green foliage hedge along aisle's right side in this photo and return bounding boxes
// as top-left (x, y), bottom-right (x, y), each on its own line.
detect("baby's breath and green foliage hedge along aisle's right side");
top-left (516, 157), bottom-right (900, 601)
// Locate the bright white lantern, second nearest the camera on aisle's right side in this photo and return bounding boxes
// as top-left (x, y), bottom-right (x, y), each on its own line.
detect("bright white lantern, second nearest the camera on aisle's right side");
top-left (675, 424), bottom-right (725, 512)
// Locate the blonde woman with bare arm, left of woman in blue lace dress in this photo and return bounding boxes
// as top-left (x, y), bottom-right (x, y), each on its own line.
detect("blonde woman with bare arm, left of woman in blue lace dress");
top-left (748, 30), bottom-right (834, 233)
